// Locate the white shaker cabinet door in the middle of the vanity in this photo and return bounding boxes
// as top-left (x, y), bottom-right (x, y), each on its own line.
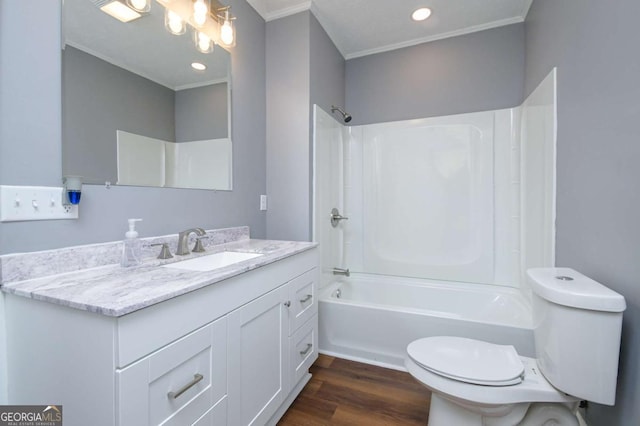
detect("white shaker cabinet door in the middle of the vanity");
top-left (227, 286), bottom-right (289, 426)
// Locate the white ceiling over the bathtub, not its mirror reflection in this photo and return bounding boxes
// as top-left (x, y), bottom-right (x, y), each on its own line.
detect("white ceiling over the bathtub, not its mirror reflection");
top-left (247, 0), bottom-right (533, 59)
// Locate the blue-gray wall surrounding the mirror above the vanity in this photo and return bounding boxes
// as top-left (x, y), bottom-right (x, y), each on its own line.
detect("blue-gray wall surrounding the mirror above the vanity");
top-left (0, 0), bottom-right (266, 254)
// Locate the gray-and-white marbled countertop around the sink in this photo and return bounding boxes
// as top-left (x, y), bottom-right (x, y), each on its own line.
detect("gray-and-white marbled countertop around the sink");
top-left (2, 239), bottom-right (317, 317)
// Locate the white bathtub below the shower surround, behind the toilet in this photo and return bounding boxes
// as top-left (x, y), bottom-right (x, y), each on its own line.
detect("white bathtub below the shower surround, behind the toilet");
top-left (319, 274), bottom-right (534, 370)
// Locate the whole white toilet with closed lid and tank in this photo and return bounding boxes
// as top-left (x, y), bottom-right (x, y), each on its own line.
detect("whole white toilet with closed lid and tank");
top-left (405, 268), bottom-right (626, 426)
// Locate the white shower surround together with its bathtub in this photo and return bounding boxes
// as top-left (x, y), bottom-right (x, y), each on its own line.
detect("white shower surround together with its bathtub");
top-left (313, 70), bottom-right (556, 369)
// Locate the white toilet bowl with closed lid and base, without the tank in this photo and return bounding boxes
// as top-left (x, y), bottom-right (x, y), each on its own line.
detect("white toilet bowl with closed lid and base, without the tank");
top-left (405, 336), bottom-right (579, 426)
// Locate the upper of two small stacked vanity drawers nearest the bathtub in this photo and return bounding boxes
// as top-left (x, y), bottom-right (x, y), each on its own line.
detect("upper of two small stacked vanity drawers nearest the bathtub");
top-left (288, 268), bottom-right (318, 336)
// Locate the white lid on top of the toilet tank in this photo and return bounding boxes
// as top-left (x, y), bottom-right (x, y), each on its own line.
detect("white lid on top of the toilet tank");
top-left (527, 268), bottom-right (627, 312)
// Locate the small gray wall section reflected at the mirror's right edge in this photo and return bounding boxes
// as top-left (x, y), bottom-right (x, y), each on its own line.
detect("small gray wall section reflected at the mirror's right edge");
top-left (175, 83), bottom-right (229, 142)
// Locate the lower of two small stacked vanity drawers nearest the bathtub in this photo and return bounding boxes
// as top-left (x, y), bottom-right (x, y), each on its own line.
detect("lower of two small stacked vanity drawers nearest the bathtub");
top-left (289, 315), bottom-right (318, 387)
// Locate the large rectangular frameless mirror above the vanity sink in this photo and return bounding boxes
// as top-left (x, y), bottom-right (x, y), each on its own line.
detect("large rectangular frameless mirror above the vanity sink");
top-left (62, 0), bottom-right (232, 190)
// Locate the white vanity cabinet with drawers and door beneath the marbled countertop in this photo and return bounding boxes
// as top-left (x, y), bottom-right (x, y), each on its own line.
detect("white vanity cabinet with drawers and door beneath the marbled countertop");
top-left (5, 248), bottom-right (319, 426)
